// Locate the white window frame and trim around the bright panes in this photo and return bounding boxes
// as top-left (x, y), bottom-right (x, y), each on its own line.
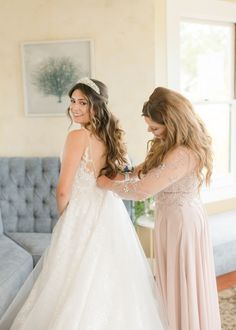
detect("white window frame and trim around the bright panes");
top-left (166, 0), bottom-right (236, 203)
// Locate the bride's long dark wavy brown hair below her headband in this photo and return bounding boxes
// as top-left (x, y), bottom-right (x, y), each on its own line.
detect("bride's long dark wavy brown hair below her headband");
top-left (67, 79), bottom-right (127, 178)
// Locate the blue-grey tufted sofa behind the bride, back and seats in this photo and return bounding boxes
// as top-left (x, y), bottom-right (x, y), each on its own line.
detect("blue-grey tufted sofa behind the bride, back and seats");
top-left (0, 157), bottom-right (132, 318)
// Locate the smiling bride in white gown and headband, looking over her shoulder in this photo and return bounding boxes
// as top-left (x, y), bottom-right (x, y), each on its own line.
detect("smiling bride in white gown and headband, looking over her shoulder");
top-left (0, 78), bottom-right (166, 330)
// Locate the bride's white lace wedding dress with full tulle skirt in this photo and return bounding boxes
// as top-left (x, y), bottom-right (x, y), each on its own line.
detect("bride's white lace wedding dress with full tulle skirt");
top-left (0, 136), bottom-right (166, 330)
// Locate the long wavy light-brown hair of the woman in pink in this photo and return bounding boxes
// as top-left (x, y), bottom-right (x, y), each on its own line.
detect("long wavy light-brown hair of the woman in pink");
top-left (141, 87), bottom-right (212, 186)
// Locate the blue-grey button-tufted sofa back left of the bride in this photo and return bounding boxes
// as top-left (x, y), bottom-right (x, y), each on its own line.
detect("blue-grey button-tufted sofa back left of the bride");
top-left (0, 157), bottom-right (60, 233)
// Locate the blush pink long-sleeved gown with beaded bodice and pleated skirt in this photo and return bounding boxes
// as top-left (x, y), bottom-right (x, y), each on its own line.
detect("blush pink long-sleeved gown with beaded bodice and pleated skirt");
top-left (112, 147), bottom-right (221, 330)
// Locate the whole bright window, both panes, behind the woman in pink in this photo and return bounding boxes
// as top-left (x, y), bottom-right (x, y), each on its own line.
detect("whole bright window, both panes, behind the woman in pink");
top-left (180, 20), bottom-right (236, 192)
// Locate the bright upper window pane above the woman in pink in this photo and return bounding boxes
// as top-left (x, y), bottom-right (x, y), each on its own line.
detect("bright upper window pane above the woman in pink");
top-left (180, 21), bottom-right (234, 101)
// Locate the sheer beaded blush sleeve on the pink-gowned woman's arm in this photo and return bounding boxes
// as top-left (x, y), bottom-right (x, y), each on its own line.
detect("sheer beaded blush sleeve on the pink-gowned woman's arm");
top-left (109, 147), bottom-right (196, 200)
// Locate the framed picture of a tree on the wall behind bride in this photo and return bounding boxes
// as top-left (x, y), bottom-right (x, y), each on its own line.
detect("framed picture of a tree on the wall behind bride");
top-left (21, 40), bottom-right (93, 116)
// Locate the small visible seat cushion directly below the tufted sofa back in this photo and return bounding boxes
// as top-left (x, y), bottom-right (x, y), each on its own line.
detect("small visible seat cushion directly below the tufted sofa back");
top-left (7, 232), bottom-right (51, 266)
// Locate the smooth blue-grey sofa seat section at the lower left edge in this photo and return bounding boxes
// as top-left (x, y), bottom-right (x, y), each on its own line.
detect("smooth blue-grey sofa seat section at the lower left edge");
top-left (0, 235), bottom-right (33, 318)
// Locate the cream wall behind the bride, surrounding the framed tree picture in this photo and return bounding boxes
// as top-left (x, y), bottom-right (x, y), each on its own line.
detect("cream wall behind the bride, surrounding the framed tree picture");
top-left (0, 0), bottom-right (159, 161)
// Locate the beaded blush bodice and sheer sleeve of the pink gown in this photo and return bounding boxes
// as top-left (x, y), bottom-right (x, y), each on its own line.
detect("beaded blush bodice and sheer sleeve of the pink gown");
top-left (108, 147), bottom-right (198, 204)
